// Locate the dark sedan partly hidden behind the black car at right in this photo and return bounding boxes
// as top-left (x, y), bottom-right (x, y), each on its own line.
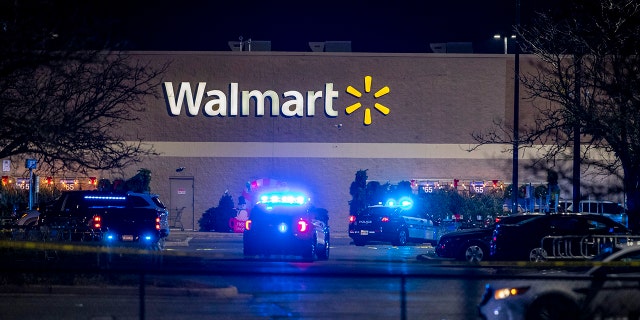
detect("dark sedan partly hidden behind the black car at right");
top-left (435, 214), bottom-right (538, 263)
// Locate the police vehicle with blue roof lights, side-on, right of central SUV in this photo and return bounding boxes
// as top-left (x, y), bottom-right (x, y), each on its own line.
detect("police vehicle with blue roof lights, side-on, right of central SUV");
top-left (349, 203), bottom-right (438, 246)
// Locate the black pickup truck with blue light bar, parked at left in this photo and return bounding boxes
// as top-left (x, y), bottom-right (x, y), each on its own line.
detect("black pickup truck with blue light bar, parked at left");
top-left (38, 191), bottom-right (169, 249)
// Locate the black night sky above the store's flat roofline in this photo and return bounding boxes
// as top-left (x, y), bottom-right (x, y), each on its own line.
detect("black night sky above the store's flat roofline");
top-left (96, 0), bottom-right (550, 53)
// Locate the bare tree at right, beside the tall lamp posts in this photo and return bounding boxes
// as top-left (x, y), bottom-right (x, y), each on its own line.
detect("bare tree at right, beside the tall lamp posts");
top-left (473, 0), bottom-right (640, 231)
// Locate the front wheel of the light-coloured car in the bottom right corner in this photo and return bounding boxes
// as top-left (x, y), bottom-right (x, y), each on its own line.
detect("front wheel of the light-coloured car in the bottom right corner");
top-left (525, 296), bottom-right (580, 320)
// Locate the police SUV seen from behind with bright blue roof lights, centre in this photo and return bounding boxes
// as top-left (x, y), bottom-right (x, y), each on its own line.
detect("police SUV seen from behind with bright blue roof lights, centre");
top-left (243, 192), bottom-right (330, 261)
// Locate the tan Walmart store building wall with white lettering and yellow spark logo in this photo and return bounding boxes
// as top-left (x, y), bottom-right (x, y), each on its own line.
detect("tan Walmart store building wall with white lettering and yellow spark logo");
top-left (102, 52), bottom-right (592, 232)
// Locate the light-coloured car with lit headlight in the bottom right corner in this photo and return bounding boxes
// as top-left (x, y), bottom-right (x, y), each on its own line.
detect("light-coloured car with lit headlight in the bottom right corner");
top-left (478, 246), bottom-right (640, 320)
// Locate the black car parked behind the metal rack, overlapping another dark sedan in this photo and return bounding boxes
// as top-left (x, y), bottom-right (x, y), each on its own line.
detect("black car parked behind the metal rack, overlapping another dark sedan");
top-left (490, 214), bottom-right (631, 261)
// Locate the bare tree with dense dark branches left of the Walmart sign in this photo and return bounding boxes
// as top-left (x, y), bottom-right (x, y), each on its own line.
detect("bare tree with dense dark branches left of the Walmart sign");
top-left (0, 0), bottom-right (166, 175)
